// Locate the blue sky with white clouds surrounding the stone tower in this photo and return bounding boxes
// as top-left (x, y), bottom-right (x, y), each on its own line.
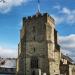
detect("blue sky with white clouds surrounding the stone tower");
top-left (0, 0), bottom-right (75, 59)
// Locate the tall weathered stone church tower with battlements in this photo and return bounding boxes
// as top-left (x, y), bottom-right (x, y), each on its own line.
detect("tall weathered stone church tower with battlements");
top-left (17, 13), bottom-right (60, 75)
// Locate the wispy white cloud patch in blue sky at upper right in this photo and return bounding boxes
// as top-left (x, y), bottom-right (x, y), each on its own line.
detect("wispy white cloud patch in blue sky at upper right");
top-left (53, 6), bottom-right (75, 25)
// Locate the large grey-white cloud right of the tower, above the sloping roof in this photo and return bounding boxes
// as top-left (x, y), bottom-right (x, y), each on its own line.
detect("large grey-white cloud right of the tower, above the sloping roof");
top-left (58, 34), bottom-right (75, 60)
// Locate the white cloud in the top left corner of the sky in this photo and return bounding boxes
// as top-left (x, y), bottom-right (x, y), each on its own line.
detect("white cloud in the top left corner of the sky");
top-left (0, 0), bottom-right (28, 13)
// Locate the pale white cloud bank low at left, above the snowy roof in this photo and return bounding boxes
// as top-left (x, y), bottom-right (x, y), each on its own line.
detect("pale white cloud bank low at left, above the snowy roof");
top-left (0, 46), bottom-right (18, 58)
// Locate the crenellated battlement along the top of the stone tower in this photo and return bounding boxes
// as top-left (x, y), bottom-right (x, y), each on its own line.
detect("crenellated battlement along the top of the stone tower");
top-left (23, 13), bottom-right (55, 23)
